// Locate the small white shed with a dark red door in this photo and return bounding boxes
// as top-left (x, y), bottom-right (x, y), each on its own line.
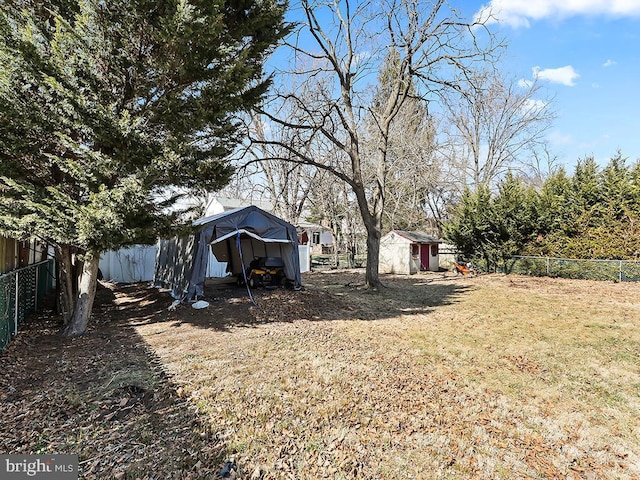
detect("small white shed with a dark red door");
top-left (380, 230), bottom-right (442, 275)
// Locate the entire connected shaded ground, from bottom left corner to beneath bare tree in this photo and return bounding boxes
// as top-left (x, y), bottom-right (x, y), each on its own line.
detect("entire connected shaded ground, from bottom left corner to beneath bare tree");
top-left (0, 273), bottom-right (473, 479)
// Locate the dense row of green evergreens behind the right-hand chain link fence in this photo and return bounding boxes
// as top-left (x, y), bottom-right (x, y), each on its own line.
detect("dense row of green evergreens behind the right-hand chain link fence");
top-left (445, 152), bottom-right (640, 270)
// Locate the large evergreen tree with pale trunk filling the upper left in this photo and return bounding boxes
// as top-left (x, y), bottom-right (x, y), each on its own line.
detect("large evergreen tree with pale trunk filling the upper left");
top-left (0, 0), bottom-right (287, 335)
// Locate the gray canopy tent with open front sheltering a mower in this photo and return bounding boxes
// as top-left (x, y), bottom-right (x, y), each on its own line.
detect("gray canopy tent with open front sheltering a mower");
top-left (154, 205), bottom-right (301, 300)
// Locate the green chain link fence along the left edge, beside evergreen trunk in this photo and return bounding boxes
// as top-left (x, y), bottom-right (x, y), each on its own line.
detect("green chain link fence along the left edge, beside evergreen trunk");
top-left (0, 260), bottom-right (55, 352)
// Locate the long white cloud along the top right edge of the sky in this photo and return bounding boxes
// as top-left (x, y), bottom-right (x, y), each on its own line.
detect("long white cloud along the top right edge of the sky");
top-left (475, 0), bottom-right (640, 28)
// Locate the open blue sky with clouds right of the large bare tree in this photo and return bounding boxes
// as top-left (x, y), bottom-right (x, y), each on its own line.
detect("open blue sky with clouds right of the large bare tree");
top-left (464, 0), bottom-right (640, 166)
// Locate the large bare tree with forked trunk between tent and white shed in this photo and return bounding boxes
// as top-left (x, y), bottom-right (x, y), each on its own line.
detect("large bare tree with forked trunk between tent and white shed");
top-left (250, 0), bottom-right (496, 288)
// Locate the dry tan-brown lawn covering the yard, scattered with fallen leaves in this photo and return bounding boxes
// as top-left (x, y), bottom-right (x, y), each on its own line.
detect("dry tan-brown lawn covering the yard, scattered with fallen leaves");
top-left (0, 272), bottom-right (640, 479)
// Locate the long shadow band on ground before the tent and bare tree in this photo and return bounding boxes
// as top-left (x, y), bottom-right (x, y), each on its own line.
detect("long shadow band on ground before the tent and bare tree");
top-left (149, 271), bottom-right (474, 331)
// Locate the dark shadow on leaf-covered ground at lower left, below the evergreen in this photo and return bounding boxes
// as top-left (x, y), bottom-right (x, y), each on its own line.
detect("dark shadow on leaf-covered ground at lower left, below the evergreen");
top-left (0, 285), bottom-right (235, 479)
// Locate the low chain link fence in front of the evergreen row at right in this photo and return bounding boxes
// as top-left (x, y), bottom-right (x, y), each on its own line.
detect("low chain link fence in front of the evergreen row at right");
top-left (505, 256), bottom-right (640, 282)
